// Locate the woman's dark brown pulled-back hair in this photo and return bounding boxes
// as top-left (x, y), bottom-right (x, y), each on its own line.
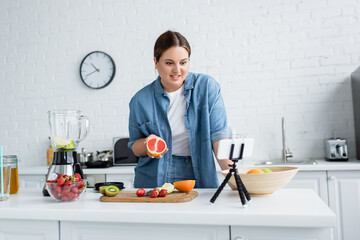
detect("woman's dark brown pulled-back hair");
top-left (154, 30), bottom-right (191, 61)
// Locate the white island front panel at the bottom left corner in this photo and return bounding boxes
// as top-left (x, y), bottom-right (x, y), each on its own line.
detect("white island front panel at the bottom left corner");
top-left (0, 219), bottom-right (59, 240)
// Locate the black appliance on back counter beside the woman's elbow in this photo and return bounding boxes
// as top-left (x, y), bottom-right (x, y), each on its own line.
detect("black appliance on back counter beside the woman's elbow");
top-left (113, 137), bottom-right (139, 166)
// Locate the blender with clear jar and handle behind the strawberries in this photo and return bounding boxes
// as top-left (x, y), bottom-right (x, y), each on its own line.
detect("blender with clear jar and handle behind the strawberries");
top-left (43, 110), bottom-right (89, 196)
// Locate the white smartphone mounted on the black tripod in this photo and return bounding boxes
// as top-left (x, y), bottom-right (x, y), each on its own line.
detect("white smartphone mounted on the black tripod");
top-left (216, 138), bottom-right (254, 160)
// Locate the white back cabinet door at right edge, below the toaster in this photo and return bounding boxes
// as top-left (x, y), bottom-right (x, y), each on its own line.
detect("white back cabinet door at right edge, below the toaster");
top-left (328, 171), bottom-right (360, 240)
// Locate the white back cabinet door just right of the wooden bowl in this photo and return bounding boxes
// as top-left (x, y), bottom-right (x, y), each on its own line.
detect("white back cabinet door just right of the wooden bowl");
top-left (285, 171), bottom-right (328, 204)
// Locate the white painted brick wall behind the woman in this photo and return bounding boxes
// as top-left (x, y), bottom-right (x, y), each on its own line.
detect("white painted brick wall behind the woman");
top-left (0, 0), bottom-right (360, 166)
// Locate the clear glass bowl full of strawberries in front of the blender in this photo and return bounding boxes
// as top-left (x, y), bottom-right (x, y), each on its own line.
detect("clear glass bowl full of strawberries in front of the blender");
top-left (46, 173), bottom-right (86, 202)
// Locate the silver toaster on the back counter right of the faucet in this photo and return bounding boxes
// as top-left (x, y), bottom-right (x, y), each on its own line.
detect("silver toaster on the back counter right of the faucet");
top-left (325, 138), bottom-right (349, 161)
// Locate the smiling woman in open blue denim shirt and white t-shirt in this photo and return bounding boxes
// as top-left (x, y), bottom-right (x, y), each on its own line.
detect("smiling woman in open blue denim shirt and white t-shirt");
top-left (129, 31), bottom-right (231, 188)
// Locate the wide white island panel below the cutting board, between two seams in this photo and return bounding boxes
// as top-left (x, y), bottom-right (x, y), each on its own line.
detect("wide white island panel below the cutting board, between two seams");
top-left (60, 221), bottom-right (229, 240)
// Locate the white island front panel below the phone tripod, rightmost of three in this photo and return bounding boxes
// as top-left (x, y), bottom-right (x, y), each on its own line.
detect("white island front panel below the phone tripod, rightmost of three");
top-left (230, 226), bottom-right (331, 240)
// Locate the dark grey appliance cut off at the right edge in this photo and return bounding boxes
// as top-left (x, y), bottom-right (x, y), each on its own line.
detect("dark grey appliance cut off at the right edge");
top-left (351, 67), bottom-right (360, 160)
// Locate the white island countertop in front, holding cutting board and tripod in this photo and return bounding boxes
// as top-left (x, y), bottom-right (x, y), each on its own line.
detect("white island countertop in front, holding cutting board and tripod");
top-left (0, 189), bottom-right (336, 228)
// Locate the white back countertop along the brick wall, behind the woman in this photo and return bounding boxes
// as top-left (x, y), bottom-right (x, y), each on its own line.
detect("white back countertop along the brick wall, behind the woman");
top-left (19, 159), bottom-right (360, 175)
